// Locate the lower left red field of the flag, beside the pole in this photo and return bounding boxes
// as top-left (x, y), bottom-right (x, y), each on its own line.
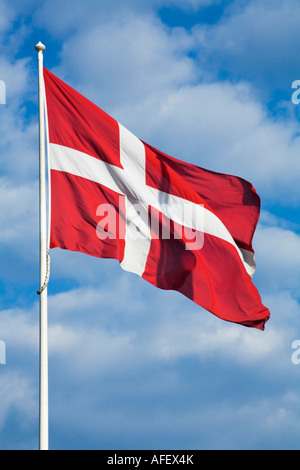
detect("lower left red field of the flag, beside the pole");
top-left (50, 170), bottom-right (125, 261)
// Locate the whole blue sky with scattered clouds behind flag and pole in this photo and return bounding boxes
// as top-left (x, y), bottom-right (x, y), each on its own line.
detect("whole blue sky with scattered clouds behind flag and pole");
top-left (0, 0), bottom-right (300, 449)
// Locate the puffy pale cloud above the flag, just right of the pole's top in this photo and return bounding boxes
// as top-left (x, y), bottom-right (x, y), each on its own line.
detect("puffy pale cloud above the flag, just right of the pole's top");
top-left (57, 14), bottom-right (196, 109)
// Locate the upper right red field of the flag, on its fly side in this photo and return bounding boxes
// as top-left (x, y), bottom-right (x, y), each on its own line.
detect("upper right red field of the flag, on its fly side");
top-left (145, 143), bottom-right (260, 251)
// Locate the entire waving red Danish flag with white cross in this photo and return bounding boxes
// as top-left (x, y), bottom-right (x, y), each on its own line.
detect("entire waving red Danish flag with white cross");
top-left (44, 69), bottom-right (270, 330)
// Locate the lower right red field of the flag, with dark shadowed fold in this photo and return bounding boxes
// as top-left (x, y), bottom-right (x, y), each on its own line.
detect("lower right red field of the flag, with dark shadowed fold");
top-left (143, 208), bottom-right (269, 329)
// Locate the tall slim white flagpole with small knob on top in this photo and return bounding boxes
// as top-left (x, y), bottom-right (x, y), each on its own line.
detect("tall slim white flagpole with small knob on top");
top-left (35, 42), bottom-right (49, 450)
